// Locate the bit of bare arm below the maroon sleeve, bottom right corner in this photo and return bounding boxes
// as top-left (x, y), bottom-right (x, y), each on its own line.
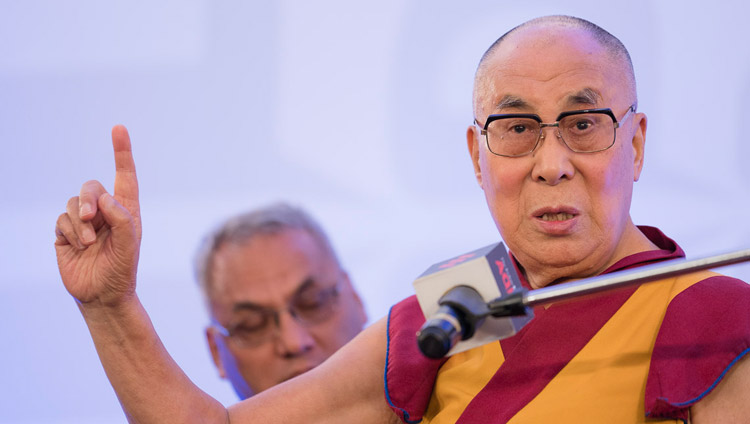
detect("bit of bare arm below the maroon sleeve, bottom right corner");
top-left (690, 356), bottom-right (750, 424)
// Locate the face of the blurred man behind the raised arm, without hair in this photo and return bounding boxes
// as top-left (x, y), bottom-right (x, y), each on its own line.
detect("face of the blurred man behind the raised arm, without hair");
top-left (206, 229), bottom-right (366, 398)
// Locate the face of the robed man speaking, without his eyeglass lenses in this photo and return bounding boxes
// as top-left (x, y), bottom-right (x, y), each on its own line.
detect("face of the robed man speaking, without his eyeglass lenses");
top-left (467, 27), bottom-right (646, 286)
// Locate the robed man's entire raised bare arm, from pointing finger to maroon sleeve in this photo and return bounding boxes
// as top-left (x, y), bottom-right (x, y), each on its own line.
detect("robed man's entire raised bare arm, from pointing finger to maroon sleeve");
top-left (55, 126), bottom-right (398, 424)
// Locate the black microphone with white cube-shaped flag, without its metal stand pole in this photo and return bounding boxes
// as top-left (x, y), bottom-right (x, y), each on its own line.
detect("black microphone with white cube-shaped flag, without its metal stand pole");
top-left (413, 243), bottom-right (533, 358)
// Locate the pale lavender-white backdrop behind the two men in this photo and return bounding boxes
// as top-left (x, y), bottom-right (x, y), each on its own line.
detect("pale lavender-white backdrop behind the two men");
top-left (0, 0), bottom-right (750, 423)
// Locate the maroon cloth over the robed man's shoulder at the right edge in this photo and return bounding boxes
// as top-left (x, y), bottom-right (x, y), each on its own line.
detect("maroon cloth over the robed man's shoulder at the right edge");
top-left (646, 273), bottom-right (750, 416)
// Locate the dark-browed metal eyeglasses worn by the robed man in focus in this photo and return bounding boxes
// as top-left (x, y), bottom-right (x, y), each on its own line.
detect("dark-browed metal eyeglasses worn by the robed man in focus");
top-left (474, 105), bottom-right (635, 158)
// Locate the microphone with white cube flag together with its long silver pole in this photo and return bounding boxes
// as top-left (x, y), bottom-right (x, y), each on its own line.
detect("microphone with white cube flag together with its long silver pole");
top-left (414, 243), bottom-right (750, 359)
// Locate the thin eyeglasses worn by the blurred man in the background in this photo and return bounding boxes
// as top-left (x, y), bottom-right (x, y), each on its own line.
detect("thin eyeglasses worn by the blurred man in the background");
top-left (211, 280), bottom-right (340, 347)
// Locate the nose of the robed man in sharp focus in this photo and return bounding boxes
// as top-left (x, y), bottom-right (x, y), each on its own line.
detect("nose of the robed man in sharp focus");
top-left (531, 127), bottom-right (575, 185)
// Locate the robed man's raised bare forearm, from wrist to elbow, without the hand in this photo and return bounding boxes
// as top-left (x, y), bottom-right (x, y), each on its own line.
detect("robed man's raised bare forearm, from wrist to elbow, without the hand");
top-left (79, 295), bottom-right (228, 424)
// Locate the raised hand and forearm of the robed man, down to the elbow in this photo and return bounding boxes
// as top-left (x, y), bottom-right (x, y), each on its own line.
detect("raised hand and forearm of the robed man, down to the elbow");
top-left (55, 126), bottom-right (228, 423)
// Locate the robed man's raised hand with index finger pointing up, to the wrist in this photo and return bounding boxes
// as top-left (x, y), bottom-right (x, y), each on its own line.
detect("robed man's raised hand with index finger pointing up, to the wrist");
top-left (55, 125), bottom-right (141, 305)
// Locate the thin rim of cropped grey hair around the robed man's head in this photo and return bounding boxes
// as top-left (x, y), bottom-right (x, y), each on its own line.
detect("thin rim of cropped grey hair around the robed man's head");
top-left (473, 15), bottom-right (637, 113)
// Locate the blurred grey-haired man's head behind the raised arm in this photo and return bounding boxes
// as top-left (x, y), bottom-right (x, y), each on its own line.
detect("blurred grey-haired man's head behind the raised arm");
top-left (195, 203), bottom-right (367, 399)
